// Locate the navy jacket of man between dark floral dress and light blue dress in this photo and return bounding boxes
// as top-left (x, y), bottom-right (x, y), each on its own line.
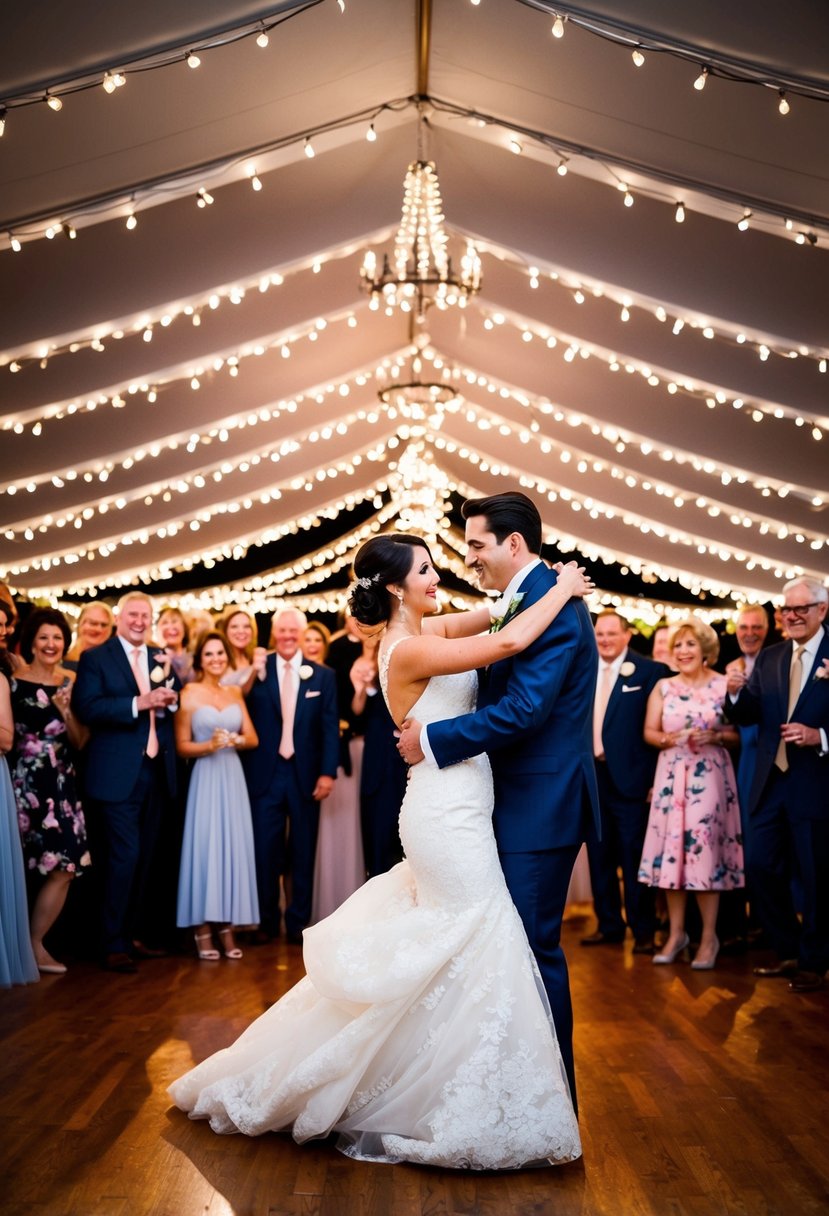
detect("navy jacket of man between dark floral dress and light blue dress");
top-left (72, 636), bottom-right (181, 803)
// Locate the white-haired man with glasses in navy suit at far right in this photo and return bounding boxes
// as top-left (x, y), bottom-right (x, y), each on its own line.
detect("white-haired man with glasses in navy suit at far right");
top-left (724, 578), bottom-right (829, 992)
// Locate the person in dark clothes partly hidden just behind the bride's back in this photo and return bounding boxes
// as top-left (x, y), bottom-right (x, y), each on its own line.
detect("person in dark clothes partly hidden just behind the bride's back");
top-left (351, 634), bottom-right (408, 878)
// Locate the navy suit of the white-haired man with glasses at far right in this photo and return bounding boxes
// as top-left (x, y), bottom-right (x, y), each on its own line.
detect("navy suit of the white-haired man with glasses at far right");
top-left (724, 630), bottom-right (829, 974)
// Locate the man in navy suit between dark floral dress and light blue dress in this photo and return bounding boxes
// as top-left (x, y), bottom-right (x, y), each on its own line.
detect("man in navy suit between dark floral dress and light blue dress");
top-left (72, 592), bottom-right (180, 973)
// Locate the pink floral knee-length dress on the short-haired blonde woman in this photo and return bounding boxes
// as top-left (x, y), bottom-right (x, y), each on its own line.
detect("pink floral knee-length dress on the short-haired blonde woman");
top-left (638, 675), bottom-right (745, 891)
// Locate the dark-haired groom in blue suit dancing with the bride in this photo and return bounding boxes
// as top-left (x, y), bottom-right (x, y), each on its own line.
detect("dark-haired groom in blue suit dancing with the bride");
top-left (399, 492), bottom-right (599, 1107)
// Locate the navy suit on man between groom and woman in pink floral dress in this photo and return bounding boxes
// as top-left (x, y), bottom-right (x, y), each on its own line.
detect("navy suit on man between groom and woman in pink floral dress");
top-left (587, 649), bottom-right (671, 941)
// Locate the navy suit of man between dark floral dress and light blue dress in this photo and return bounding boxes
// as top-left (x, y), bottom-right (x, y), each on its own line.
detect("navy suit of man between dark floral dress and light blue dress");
top-left (72, 636), bottom-right (181, 953)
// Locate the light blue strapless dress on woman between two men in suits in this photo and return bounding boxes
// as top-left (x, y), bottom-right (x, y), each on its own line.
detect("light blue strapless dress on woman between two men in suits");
top-left (176, 705), bottom-right (259, 927)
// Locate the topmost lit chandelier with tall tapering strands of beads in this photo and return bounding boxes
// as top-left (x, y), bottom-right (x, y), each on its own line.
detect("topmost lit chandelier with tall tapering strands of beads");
top-left (360, 159), bottom-right (480, 320)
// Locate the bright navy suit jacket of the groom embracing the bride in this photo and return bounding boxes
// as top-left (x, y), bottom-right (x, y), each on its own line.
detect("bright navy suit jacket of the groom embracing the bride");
top-left (429, 563), bottom-right (600, 852)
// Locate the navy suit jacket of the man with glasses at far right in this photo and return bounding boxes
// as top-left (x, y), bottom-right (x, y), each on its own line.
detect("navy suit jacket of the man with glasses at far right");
top-left (723, 630), bottom-right (829, 820)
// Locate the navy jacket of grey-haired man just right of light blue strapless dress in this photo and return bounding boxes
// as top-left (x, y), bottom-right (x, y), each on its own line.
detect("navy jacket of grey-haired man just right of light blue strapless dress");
top-left (242, 654), bottom-right (339, 798)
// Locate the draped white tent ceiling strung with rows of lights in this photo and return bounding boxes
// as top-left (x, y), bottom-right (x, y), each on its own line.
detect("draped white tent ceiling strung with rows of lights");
top-left (0, 0), bottom-right (829, 608)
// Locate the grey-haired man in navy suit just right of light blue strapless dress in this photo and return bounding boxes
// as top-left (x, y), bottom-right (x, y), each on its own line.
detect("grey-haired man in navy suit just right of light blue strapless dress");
top-left (242, 608), bottom-right (339, 944)
